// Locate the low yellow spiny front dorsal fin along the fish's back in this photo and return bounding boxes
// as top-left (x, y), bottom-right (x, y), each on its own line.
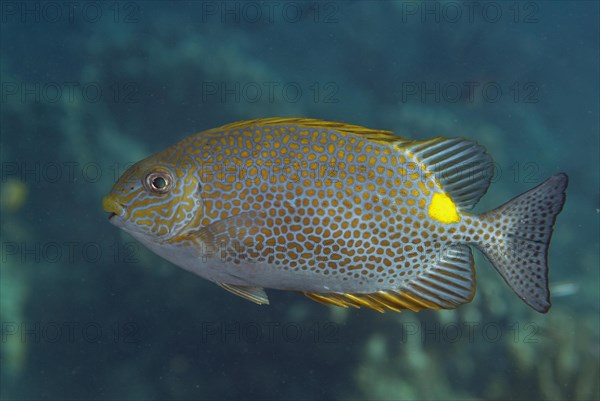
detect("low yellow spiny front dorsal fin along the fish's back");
top-left (210, 117), bottom-right (410, 143)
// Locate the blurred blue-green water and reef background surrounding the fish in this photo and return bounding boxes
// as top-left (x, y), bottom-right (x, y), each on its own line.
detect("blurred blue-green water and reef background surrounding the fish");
top-left (0, 1), bottom-right (600, 400)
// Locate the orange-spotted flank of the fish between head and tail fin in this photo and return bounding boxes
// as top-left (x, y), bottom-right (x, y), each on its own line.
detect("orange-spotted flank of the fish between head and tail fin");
top-left (162, 124), bottom-right (487, 292)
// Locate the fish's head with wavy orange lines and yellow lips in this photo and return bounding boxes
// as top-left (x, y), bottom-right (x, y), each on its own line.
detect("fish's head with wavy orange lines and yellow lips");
top-left (102, 149), bottom-right (202, 243)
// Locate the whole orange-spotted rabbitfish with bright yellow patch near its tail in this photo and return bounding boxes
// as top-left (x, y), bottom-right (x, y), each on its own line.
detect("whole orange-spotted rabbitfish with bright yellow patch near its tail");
top-left (102, 117), bottom-right (568, 313)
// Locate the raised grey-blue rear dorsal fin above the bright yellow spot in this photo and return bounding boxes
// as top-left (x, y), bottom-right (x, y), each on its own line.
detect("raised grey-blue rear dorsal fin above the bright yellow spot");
top-left (401, 138), bottom-right (494, 209)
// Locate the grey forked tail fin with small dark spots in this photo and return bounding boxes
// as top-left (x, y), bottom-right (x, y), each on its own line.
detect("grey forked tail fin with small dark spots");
top-left (477, 173), bottom-right (568, 313)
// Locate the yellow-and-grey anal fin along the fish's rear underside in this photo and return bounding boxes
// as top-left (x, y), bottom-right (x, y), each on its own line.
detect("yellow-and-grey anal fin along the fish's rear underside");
top-left (304, 245), bottom-right (475, 312)
